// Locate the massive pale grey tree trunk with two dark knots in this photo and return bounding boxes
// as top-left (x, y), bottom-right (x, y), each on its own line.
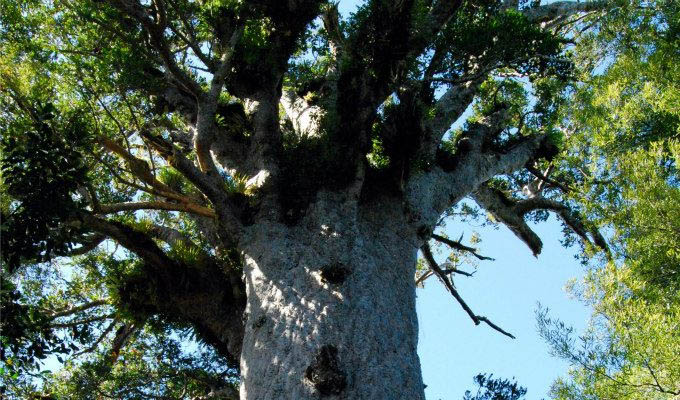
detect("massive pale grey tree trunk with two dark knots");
top-left (236, 193), bottom-right (424, 400)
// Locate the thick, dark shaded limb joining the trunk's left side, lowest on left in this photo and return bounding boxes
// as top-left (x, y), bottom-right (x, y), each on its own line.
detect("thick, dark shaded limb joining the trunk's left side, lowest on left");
top-left (80, 214), bottom-right (245, 365)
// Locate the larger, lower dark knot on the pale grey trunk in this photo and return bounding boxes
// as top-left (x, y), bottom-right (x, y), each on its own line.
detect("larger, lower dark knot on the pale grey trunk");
top-left (305, 344), bottom-right (347, 396)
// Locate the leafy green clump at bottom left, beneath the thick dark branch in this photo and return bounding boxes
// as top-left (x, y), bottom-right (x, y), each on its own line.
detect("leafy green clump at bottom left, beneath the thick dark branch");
top-left (9, 322), bottom-right (236, 400)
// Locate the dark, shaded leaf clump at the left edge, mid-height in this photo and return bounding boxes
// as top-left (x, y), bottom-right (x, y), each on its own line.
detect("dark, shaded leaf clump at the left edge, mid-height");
top-left (0, 103), bottom-right (87, 271)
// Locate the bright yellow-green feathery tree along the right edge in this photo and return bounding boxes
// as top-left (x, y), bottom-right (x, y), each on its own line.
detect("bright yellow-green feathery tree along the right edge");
top-left (539, 1), bottom-right (680, 399)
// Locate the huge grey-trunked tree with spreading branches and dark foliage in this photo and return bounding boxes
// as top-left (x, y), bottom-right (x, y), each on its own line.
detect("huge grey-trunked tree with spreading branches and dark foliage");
top-left (0, 0), bottom-right (616, 399)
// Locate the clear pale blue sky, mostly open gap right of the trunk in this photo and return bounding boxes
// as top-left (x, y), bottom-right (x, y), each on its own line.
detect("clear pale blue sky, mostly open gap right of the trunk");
top-left (332, 0), bottom-right (590, 400)
